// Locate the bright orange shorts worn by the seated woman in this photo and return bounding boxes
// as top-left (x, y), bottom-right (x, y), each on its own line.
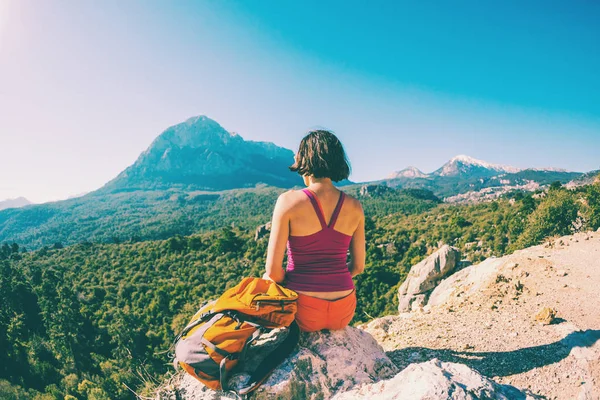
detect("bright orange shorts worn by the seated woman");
top-left (296, 290), bottom-right (356, 332)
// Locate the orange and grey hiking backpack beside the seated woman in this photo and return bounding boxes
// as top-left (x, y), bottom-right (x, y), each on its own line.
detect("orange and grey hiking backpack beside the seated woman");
top-left (175, 278), bottom-right (300, 396)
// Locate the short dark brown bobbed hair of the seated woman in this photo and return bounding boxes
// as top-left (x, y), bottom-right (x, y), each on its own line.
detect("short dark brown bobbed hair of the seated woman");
top-left (289, 130), bottom-right (350, 182)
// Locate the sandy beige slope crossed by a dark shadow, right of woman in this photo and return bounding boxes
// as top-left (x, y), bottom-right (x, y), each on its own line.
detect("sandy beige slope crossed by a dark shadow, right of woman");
top-left (362, 232), bottom-right (600, 400)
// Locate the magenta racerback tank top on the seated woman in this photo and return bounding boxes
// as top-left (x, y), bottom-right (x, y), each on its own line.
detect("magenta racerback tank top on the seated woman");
top-left (285, 189), bottom-right (354, 292)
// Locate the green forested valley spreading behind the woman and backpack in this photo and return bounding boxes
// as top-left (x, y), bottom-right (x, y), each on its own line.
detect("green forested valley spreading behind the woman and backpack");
top-left (0, 185), bottom-right (600, 399)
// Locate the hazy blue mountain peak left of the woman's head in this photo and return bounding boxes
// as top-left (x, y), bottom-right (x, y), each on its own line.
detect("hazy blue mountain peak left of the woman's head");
top-left (100, 116), bottom-right (302, 192)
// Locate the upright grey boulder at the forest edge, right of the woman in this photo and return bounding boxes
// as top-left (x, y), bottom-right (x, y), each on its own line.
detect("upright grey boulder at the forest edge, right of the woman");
top-left (398, 245), bottom-right (460, 312)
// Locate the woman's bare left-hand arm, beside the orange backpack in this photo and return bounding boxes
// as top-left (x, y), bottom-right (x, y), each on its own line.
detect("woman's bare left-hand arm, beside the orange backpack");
top-left (263, 192), bottom-right (290, 283)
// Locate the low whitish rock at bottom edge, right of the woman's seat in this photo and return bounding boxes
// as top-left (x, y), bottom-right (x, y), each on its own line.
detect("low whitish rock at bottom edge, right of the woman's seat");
top-left (332, 359), bottom-right (535, 400)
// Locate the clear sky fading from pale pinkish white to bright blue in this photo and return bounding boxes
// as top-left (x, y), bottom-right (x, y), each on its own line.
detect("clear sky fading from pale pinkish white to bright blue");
top-left (0, 0), bottom-right (600, 202)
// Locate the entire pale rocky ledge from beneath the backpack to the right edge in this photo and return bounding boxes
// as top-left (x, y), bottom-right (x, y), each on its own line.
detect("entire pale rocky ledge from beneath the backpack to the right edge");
top-left (157, 232), bottom-right (600, 400)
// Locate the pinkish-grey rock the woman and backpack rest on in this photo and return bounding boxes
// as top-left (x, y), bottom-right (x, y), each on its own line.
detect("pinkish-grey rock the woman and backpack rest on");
top-left (158, 327), bottom-right (398, 400)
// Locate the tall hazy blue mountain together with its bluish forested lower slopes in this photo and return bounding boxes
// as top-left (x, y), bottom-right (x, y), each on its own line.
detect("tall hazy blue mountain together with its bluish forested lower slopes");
top-left (0, 116), bottom-right (364, 248)
